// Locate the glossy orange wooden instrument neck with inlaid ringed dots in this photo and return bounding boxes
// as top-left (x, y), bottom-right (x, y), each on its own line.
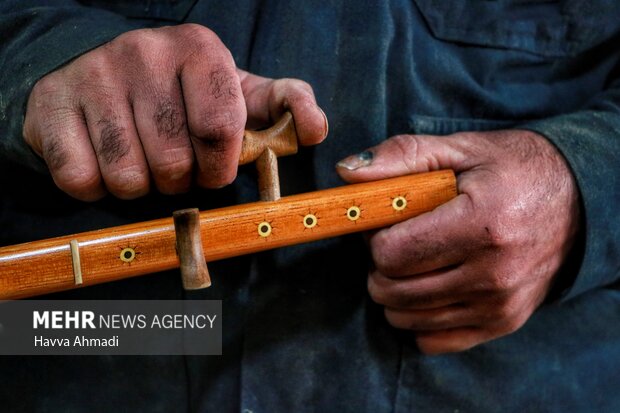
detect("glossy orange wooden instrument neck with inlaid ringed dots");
top-left (0, 171), bottom-right (456, 299)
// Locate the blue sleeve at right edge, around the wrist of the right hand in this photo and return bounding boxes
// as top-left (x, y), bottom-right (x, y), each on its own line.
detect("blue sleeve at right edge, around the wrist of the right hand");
top-left (520, 74), bottom-right (620, 299)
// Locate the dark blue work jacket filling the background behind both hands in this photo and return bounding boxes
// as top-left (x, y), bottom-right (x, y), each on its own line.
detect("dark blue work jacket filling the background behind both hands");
top-left (0, 0), bottom-right (620, 413)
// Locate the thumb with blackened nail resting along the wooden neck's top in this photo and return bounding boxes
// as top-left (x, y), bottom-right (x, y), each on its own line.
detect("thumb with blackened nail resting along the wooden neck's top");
top-left (336, 135), bottom-right (466, 182)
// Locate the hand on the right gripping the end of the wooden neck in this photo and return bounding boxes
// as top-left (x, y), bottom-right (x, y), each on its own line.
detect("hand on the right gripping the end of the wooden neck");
top-left (338, 130), bottom-right (579, 354)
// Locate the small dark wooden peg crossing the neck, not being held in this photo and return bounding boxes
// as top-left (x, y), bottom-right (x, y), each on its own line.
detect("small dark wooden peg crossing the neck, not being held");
top-left (172, 208), bottom-right (211, 290)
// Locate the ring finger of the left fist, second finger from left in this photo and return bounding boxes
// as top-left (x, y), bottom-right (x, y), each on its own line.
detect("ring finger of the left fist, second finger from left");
top-left (83, 92), bottom-right (149, 199)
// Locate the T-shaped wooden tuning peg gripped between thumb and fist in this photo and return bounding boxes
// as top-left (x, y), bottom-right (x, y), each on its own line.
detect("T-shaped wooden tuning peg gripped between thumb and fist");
top-left (239, 112), bottom-right (297, 201)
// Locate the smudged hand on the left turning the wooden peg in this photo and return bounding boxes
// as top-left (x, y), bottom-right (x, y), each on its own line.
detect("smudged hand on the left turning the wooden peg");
top-left (23, 24), bottom-right (327, 201)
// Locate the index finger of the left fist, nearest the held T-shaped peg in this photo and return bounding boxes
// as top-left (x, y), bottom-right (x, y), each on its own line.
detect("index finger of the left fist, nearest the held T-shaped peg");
top-left (180, 36), bottom-right (247, 188)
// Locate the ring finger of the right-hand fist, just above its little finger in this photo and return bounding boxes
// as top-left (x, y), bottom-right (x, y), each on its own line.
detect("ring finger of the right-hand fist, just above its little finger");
top-left (384, 304), bottom-right (476, 331)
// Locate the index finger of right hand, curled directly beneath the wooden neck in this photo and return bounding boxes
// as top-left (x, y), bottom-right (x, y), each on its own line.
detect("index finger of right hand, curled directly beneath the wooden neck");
top-left (370, 193), bottom-right (487, 277)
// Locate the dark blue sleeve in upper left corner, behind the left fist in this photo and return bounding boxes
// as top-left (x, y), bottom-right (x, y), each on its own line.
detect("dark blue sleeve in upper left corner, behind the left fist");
top-left (0, 0), bottom-right (138, 171)
